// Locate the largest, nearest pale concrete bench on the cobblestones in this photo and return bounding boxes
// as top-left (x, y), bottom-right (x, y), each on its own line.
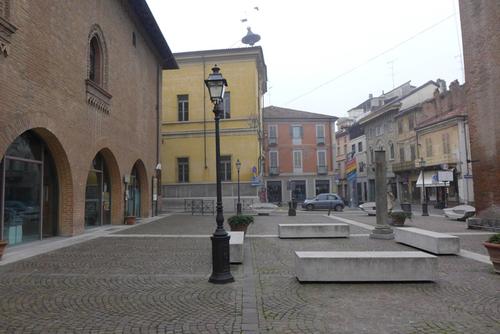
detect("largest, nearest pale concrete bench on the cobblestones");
top-left (295, 251), bottom-right (438, 282)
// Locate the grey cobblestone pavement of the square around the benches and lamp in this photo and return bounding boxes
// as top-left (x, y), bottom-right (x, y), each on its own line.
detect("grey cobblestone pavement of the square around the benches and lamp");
top-left (0, 212), bottom-right (500, 334)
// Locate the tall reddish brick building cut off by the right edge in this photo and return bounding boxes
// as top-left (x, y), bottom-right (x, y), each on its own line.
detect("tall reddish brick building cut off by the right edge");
top-left (459, 0), bottom-right (500, 230)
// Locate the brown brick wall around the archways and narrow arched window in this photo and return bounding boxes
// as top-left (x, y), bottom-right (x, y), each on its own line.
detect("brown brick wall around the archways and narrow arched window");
top-left (0, 0), bottom-right (158, 235)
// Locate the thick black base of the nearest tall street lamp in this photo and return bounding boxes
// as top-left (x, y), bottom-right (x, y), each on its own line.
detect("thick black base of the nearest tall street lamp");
top-left (208, 231), bottom-right (234, 284)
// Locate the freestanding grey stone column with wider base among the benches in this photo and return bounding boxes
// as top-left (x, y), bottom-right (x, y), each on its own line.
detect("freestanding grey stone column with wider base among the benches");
top-left (370, 151), bottom-right (394, 239)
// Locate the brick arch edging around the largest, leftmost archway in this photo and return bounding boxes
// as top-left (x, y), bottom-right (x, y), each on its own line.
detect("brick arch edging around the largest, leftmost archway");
top-left (2, 126), bottom-right (75, 236)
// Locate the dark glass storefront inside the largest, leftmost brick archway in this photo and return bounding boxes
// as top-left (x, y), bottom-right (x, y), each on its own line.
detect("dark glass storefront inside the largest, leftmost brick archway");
top-left (0, 131), bottom-right (59, 245)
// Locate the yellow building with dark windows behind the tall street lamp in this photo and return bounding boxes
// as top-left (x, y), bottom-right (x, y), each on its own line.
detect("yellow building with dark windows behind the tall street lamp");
top-left (161, 47), bottom-right (267, 211)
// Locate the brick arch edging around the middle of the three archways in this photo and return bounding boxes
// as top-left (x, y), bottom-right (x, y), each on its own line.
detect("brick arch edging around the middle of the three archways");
top-left (88, 147), bottom-right (123, 225)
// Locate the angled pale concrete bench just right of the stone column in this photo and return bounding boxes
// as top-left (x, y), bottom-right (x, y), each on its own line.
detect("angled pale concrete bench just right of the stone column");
top-left (395, 227), bottom-right (460, 254)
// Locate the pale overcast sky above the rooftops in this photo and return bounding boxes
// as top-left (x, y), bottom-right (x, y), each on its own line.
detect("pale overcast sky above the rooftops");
top-left (147, 0), bottom-right (464, 116)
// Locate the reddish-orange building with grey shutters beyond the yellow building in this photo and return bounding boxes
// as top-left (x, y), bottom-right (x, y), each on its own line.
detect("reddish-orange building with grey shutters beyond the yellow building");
top-left (263, 106), bottom-right (337, 203)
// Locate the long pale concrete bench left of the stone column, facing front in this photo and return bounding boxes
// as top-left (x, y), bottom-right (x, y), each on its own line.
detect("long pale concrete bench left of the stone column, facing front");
top-left (278, 223), bottom-right (349, 239)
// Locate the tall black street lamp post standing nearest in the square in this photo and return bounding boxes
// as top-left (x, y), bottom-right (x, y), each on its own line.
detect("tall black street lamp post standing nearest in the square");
top-left (205, 65), bottom-right (234, 284)
